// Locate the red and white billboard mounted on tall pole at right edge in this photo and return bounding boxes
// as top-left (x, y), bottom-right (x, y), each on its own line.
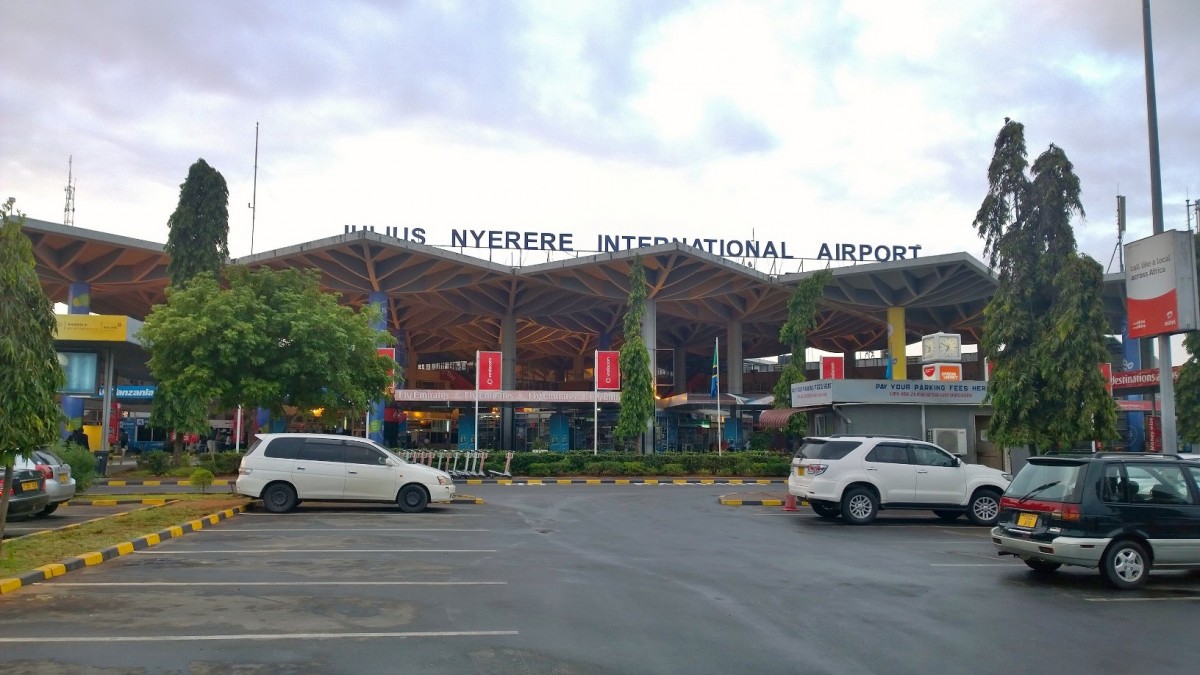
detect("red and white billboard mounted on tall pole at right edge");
top-left (1126, 229), bottom-right (1198, 338)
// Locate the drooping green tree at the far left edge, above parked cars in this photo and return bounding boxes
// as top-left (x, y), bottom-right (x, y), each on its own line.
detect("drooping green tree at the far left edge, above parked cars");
top-left (0, 197), bottom-right (66, 540)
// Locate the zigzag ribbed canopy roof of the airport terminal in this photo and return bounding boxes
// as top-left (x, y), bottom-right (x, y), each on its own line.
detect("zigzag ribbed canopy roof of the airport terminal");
top-left (24, 219), bottom-right (1124, 368)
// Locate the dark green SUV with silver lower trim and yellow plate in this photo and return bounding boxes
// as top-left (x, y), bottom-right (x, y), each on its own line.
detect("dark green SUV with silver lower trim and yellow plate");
top-left (991, 453), bottom-right (1200, 589)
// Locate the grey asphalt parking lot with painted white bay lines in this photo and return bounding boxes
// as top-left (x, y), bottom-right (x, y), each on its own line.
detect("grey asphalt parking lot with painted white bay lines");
top-left (0, 484), bottom-right (1200, 674)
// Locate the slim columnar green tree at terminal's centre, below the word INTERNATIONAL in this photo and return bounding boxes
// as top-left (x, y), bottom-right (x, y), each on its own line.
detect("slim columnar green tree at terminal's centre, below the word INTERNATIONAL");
top-left (613, 256), bottom-right (654, 449)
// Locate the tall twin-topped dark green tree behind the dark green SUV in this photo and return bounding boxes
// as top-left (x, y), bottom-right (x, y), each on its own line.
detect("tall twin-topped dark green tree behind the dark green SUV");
top-left (973, 119), bottom-right (1116, 452)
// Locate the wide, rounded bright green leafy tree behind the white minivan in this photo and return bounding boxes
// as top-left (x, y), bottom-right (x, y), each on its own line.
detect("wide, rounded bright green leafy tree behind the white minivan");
top-left (140, 268), bottom-right (395, 432)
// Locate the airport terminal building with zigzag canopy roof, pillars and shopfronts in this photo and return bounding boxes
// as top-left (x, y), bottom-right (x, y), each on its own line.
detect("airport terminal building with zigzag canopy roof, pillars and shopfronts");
top-left (24, 219), bottom-right (1124, 460)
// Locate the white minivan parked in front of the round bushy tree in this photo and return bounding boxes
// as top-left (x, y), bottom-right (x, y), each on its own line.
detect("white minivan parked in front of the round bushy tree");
top-left (235, 434), bottom-right (455, 513)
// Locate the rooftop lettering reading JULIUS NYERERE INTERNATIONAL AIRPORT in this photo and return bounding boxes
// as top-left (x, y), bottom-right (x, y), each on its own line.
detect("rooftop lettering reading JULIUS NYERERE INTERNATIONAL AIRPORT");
top-left (344, 225), bottom-right (920, 262)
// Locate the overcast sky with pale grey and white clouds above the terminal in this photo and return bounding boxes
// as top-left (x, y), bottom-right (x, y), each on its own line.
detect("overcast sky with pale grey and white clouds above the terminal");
top-left (0, 0), bottom-right (1200, 273)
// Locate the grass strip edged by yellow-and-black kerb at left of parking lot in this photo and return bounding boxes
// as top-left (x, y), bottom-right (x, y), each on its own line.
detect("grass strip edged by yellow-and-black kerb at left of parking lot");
top-left (0, 495), bottom-right (250, 577)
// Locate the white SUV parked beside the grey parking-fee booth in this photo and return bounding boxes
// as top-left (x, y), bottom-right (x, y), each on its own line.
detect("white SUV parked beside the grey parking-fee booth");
top-left (787, 435), bottom-right (1012, 525)
